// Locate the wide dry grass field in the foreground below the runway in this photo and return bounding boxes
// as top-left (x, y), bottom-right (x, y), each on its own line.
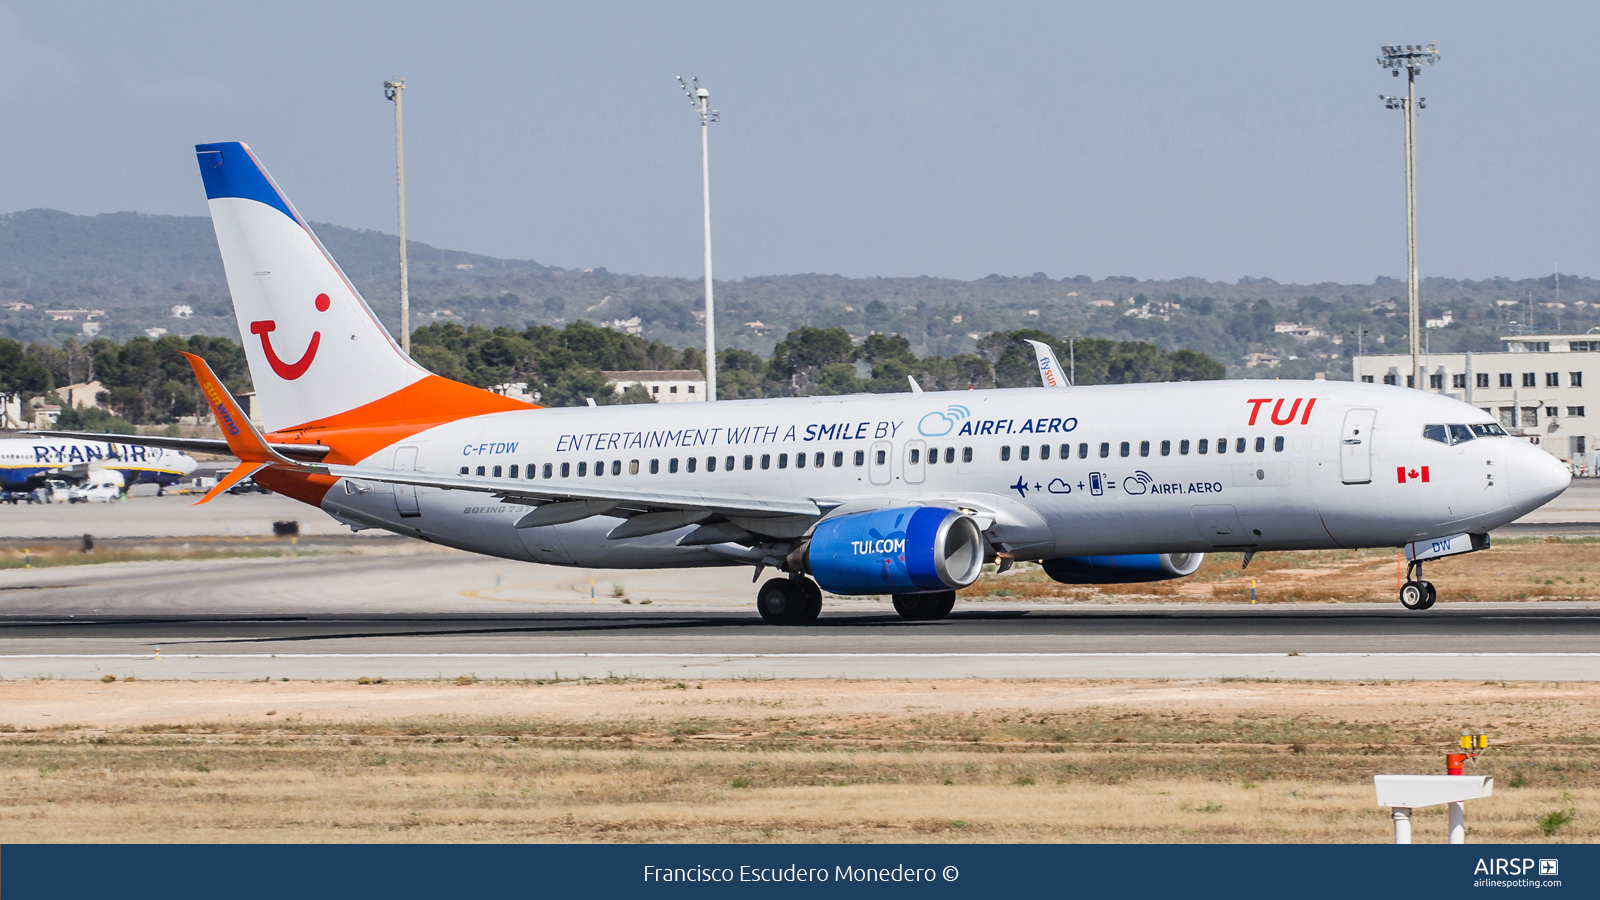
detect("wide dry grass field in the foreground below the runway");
top-left (0, 682), bottom-right (1600, 842)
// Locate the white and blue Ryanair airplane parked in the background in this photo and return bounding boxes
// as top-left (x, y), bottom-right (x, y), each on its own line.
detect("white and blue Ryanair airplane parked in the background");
top-left (0, 432), bottom-right (197, 493)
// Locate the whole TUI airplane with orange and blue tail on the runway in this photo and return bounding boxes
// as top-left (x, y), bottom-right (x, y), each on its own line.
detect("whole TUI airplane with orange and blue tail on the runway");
top-left (53, 143), bottom-right (1570, 625)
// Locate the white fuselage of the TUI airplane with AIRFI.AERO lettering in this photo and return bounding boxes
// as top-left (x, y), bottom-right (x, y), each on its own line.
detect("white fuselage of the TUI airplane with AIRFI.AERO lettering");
top-left (305, 381), bottom-right (1570, 567)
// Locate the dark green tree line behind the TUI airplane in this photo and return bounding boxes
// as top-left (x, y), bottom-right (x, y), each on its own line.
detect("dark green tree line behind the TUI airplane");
top-left (0, 320), bottom-right (1226, 432)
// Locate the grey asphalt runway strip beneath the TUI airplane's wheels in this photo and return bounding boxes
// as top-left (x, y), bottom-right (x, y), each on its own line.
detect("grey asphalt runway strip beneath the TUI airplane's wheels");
top-left (9, 604), bottom-right (1600, 681)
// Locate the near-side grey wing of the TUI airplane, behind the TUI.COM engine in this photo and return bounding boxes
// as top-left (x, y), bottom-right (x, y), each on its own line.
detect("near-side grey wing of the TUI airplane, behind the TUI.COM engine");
top-left (318, 464), bottom-right (835, 525)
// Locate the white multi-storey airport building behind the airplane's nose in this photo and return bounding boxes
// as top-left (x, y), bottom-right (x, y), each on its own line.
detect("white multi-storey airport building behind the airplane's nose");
top-left (1352, 333), bottom-right (1600, 476)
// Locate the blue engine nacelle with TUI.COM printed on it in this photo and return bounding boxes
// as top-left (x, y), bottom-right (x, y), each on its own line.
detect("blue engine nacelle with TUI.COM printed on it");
top-left (805, 506), bottom-right (984, 594)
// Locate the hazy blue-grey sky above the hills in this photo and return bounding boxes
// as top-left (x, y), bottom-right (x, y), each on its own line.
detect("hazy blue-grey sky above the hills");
top-left (0, 0), bottom-right (1600, 282)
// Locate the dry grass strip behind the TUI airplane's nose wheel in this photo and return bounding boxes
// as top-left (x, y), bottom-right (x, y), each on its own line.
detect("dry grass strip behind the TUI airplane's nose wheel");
top-left (962, 538), bottom-right (1600, 604)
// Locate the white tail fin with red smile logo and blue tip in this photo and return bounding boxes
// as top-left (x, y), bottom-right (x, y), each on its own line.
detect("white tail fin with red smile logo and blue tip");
top-left (195, 141), bottom-right (530, 438)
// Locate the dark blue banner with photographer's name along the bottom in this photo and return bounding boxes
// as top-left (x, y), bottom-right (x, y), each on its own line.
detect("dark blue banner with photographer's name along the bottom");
top-left (0, 844), bottom-right (1600, 900)
